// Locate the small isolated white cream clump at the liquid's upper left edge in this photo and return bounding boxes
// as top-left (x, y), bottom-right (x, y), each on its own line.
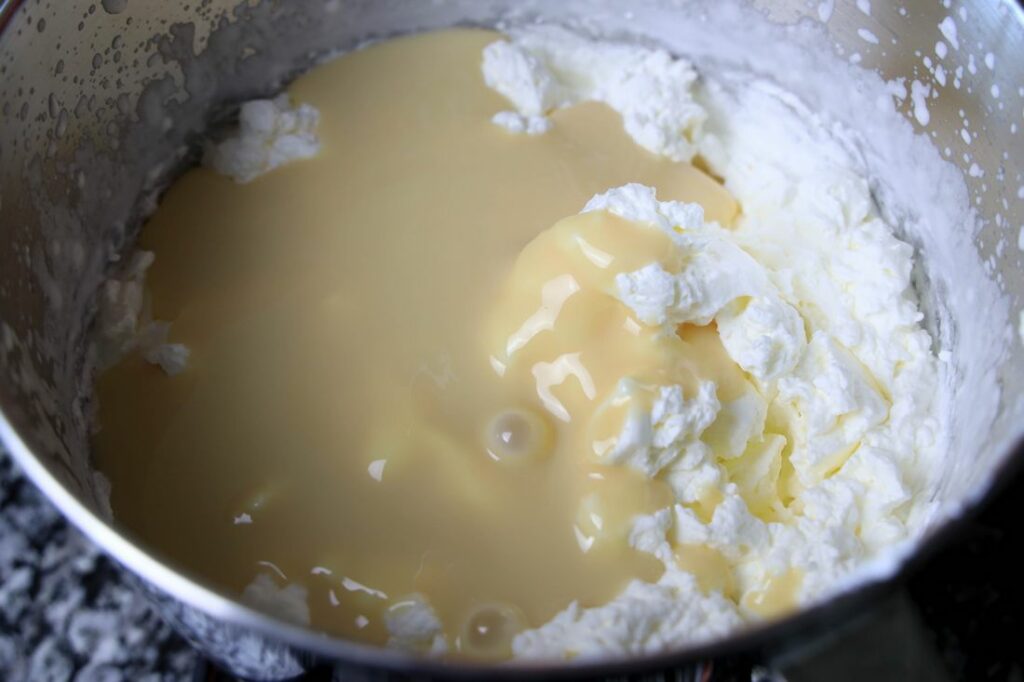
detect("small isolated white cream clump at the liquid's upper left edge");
top-left (204, 94), bottom-right (319, 182)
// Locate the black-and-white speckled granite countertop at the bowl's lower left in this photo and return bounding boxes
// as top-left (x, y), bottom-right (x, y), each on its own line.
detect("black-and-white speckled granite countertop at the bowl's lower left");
top-left (0, 452), bottom-right (196, 682)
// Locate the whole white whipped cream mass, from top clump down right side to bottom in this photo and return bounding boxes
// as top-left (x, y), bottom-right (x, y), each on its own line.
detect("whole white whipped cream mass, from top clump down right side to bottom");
top-left (484, 29), bottom-right (941, 657)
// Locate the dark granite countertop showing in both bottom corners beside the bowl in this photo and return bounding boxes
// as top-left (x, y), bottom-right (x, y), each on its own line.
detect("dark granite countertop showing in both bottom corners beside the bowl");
top-left (0, 444), bottom-right (1024, 682)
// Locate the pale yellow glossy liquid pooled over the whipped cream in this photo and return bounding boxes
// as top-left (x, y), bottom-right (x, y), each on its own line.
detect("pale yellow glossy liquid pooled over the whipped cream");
top-left (95, 30), bottom-right (749, 654)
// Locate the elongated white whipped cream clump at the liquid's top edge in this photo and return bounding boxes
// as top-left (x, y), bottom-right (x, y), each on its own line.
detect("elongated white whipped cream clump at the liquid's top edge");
top-left (483, 26), bottom-right (705, 161)
